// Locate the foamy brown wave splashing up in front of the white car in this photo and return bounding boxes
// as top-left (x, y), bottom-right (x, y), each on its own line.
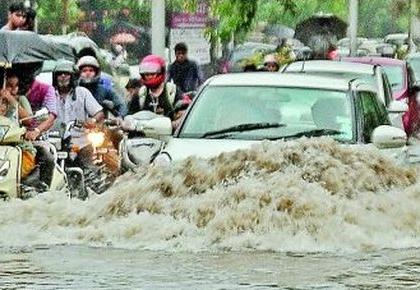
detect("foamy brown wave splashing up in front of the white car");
top-left (0, 138), bottom-right (420, 252)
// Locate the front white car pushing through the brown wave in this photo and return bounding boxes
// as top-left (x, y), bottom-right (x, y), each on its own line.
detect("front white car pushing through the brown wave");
top-left (140, 72), bottom-right (406, 163)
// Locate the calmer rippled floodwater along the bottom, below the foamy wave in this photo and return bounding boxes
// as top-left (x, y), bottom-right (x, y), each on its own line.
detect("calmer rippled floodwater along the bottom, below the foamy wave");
top-left (0, 246), bottom-right (420, 289)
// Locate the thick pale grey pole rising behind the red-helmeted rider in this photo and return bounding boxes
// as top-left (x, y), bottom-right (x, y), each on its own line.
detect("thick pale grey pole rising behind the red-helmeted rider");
top-left (152, 0), bottom-right (165, 57)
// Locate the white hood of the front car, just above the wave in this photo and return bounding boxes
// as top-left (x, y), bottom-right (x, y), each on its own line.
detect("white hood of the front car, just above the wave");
top-left (162, 138), bottom-right (261, 161)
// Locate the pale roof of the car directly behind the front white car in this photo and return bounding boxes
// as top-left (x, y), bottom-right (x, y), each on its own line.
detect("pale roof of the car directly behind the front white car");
top-left (283, 60), bottom-right (374, 75)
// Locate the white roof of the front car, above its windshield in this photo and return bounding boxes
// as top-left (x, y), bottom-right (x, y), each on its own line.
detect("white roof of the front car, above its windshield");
top-left (207, 72), bottom-right (368, 91)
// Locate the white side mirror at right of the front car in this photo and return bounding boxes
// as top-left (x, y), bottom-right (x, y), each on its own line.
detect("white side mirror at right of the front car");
top-left (371, 125), bottom-right (407, 149)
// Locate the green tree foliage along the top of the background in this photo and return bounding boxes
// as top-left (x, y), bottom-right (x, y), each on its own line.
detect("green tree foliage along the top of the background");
top-left (37, 0), bottom-right (420, 42)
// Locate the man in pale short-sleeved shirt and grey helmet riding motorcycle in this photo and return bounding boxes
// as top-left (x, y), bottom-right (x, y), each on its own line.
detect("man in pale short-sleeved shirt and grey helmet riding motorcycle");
top-left (53, 60), bottom-right (105, 168)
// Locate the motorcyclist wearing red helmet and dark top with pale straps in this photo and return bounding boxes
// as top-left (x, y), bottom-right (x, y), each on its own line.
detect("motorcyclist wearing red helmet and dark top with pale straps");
top-left (135, 54), bottom-right (181, 120)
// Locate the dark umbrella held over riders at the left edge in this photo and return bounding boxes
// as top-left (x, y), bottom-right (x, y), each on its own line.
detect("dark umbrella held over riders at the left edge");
top-left (0, 31), bottom-right (73, 67)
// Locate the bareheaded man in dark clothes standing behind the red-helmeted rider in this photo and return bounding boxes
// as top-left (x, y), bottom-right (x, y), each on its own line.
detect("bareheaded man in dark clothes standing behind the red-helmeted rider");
top-left (169, 42), bottom-right (203, 93)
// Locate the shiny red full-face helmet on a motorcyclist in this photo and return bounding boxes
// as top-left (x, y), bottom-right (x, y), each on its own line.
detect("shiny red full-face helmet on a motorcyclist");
top-left (139, 54), bottom-right (166, 89)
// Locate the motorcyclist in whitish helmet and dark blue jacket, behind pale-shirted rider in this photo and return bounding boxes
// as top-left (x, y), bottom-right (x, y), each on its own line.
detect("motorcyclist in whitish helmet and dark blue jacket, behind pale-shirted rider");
top-left (77, 56), bottom-right (127, 117)
